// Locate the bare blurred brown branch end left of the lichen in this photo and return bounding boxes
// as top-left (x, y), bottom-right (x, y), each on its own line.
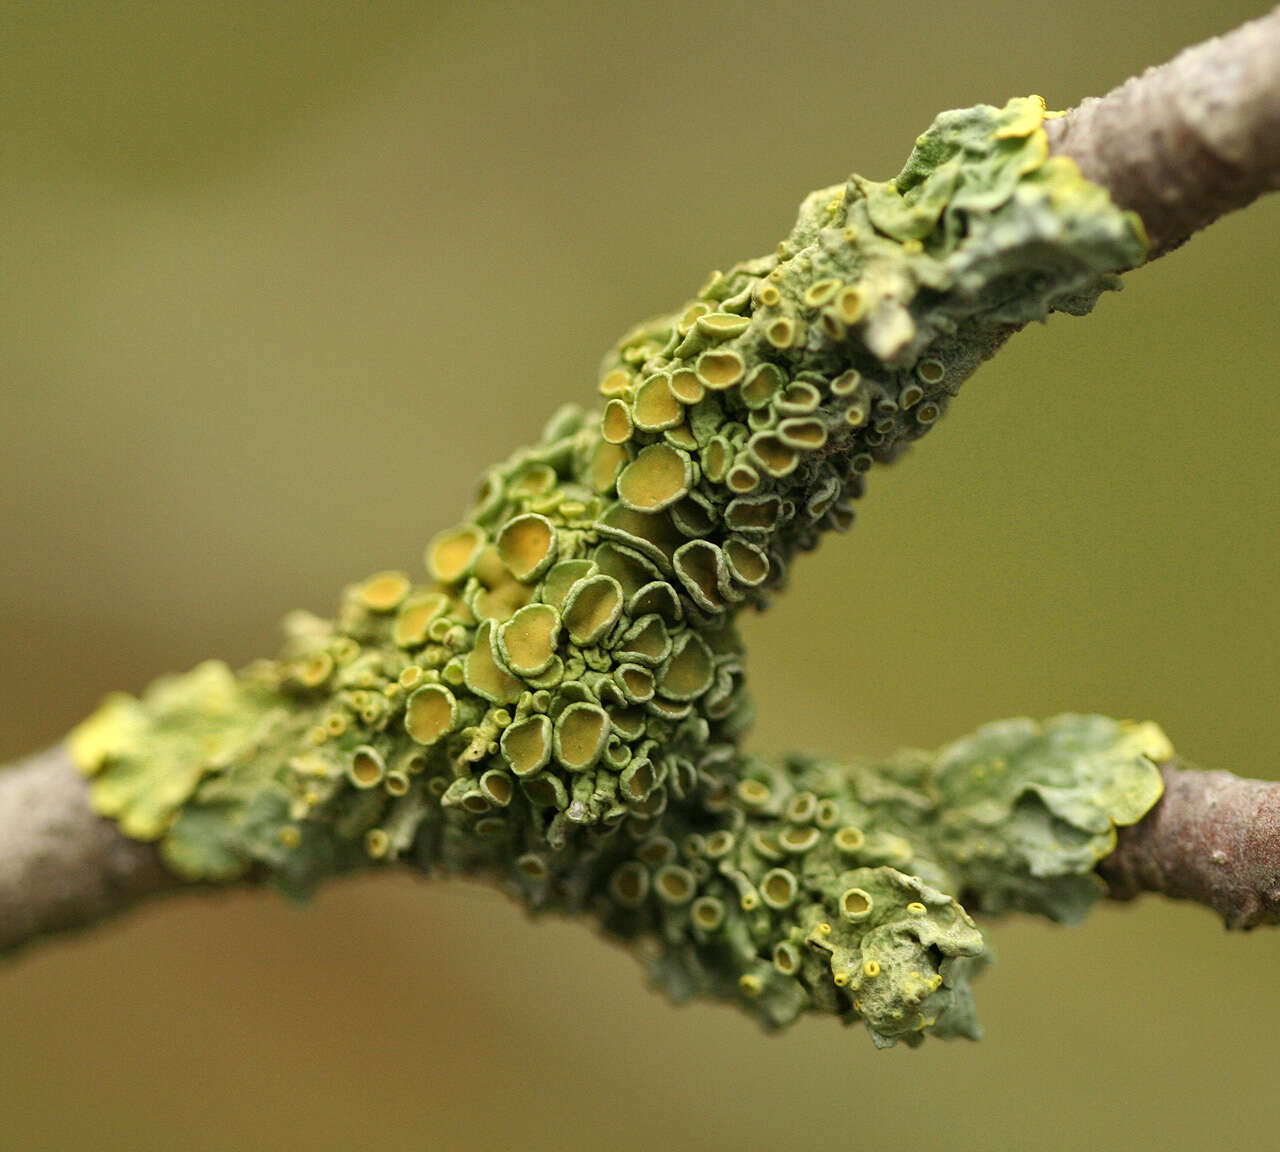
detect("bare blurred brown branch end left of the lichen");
top-left (0, 745), bottom-right (179, 952)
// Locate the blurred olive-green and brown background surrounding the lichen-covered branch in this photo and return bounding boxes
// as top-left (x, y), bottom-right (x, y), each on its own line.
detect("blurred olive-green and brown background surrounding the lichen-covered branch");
top-left (0, 0), bottom-right (1280, 1152)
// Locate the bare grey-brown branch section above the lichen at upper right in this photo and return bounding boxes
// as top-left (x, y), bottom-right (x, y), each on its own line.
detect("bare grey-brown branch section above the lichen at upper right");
top-left (1044, 8), bottom-right (1280, 260)
